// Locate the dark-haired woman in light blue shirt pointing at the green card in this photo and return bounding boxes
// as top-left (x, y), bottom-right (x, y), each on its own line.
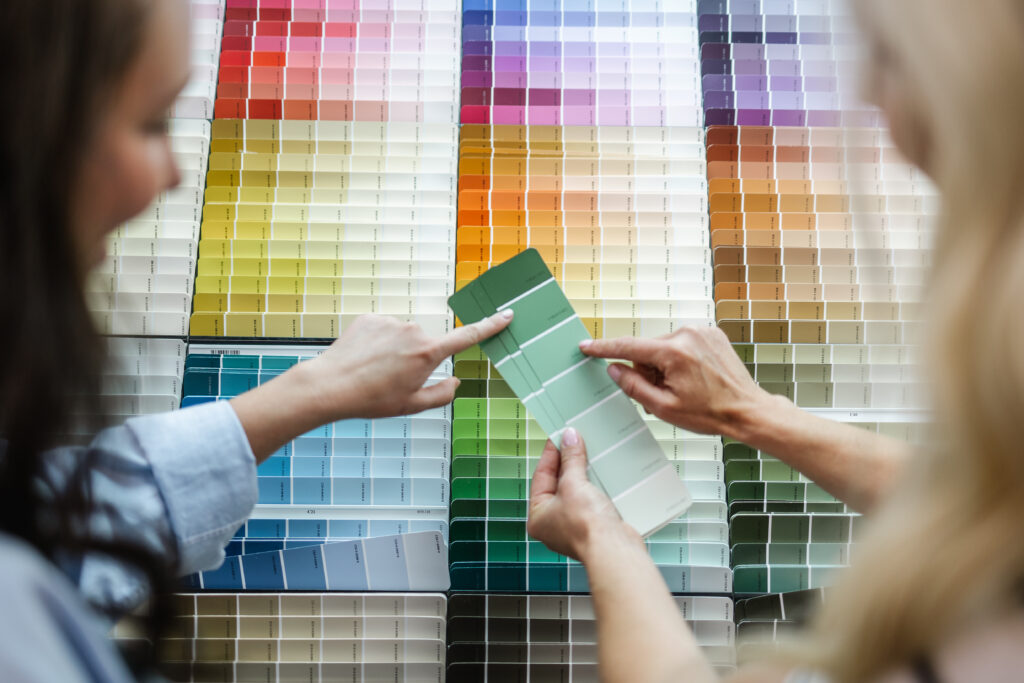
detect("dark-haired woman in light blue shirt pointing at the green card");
top-left (0, 0), bottom-right (509, 682)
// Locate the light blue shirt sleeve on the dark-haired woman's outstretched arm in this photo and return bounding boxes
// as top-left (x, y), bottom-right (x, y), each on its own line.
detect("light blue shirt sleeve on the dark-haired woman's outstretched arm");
top-left (67, 401), bottom-right (257, 593)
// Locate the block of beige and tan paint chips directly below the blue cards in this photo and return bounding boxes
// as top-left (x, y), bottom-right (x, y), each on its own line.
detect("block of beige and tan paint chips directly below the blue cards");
top-left (113, 593), bottom-right (446, 683)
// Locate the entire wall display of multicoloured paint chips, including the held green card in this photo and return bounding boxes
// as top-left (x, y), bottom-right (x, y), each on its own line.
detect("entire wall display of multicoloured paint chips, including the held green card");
top-left (73, 0), bottom-right (938, 683)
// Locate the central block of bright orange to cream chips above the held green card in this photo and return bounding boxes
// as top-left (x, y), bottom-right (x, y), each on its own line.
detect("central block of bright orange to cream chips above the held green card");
top-left (456, 124), bottom-right (715, 337)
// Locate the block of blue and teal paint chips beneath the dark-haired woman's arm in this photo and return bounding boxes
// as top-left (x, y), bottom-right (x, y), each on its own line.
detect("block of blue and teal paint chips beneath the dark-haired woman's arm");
top-left (182, 345), bottom-right (452, 591)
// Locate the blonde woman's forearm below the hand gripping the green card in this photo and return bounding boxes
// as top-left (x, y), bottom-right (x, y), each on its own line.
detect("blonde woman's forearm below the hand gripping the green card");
top-left (583, 530), bottom-right (718, 683)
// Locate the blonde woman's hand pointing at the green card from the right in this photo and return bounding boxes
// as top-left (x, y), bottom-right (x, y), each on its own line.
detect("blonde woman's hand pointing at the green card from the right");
top-left (580, 328), bottom-right (772, 436)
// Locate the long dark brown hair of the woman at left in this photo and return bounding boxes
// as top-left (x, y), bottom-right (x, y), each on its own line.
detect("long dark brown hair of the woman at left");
top-left (0, 0), bottom-right (176, 664)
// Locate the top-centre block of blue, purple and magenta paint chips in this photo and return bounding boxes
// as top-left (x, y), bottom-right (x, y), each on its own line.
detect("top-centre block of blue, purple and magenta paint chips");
top-left (461, 0), bottom-right (702, 126)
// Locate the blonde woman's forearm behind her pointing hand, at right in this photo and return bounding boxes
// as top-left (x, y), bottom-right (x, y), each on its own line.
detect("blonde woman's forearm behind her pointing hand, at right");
top-left (724, 394), bottom-right (910, 511)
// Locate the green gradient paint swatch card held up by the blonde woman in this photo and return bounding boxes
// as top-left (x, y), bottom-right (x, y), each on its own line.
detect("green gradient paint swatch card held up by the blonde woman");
top-left (449, 249), bottom-right (691, 537)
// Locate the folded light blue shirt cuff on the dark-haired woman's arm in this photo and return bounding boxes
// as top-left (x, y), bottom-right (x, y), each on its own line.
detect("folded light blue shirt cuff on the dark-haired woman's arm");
top-left (125, 400), bottom-right (257, 574)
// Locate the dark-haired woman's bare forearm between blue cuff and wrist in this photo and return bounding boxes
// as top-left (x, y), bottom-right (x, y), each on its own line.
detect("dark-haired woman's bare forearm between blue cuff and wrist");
top-left (230, 361), bottom-right (341, 463)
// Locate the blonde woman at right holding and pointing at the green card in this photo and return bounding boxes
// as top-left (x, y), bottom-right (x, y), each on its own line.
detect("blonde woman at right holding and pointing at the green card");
top-left (528, 0), bottom-right (1024, 683)
